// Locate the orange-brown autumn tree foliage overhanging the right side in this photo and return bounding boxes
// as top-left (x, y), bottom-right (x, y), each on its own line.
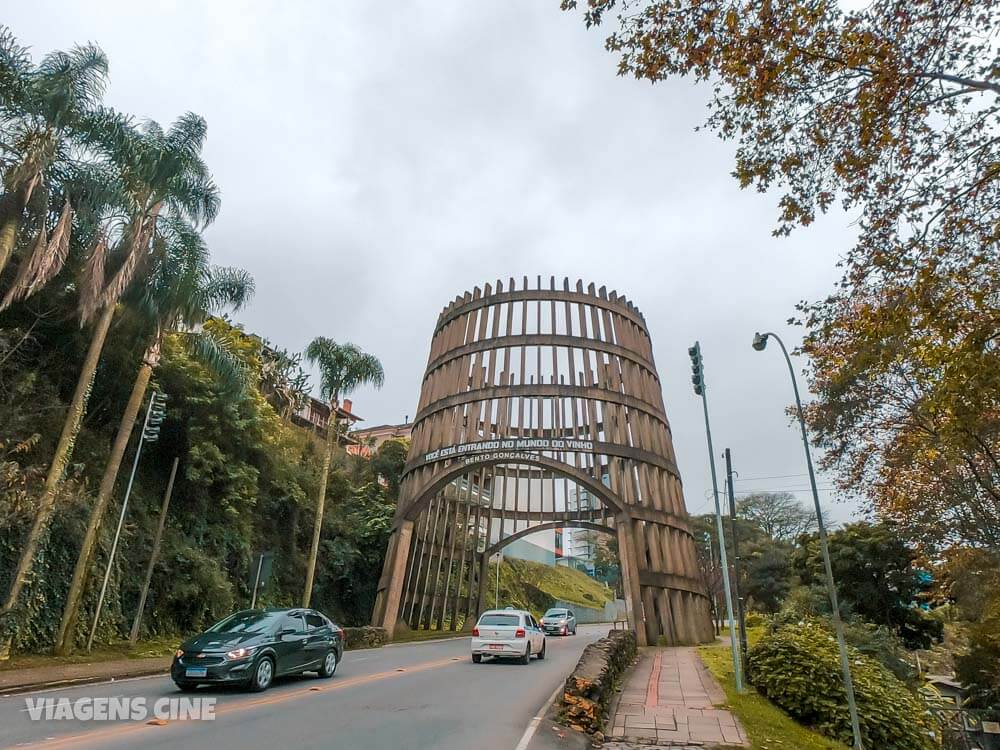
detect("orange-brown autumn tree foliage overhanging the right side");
top-left (561, 0), bottom-right (1000, 554)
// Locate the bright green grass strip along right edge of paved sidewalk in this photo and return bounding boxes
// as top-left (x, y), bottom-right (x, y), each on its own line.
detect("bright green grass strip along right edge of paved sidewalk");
top-left (698, 628), bottom-right (848, 750)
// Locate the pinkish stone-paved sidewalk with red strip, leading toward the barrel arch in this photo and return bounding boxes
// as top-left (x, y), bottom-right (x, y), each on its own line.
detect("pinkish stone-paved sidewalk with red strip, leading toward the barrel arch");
top-left (605, 648), bottom-right (750, 748)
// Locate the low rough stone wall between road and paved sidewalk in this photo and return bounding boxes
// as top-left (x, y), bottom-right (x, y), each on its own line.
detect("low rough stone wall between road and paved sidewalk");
top-left (560, 630), bottom-right (637, 734)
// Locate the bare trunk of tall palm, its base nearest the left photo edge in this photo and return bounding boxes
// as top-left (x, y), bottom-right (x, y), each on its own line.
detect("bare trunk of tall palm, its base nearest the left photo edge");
top-left (0, 305), bottom-right (115, 661)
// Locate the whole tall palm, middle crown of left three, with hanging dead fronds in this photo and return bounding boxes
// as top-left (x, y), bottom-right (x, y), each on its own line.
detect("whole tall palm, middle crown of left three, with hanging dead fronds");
top-left (0, 113), bottom-right (219, 660)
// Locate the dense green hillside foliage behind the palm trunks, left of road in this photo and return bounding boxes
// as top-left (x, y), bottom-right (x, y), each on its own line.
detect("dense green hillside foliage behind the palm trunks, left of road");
top-left (0, 310), bottom-right (405, 651)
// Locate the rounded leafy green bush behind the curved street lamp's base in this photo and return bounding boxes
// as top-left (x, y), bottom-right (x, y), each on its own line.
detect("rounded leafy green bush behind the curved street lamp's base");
top-left (748, 620), bottom-right (936, 750)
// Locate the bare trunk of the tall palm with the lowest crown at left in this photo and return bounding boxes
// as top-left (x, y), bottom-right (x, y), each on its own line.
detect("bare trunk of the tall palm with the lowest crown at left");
top-left (55, 356), bottom-right (153, 656)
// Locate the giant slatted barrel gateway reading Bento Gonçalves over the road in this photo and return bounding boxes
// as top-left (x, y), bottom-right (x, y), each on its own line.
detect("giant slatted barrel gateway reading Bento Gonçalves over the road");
top-left (373, 277), bottom-right (713, 644)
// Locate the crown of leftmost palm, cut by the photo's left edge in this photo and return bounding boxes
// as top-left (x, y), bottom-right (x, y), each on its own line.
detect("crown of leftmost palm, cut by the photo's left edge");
top-left (0, 26), bottom-right (114, 280)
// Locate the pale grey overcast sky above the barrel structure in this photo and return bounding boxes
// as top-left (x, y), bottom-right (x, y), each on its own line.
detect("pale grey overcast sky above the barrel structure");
top-left (7, 0), bottom-right (868, 522)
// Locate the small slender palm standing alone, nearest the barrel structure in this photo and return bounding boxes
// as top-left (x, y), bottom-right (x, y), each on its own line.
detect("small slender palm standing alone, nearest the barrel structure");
top-left (302, 336), bottom-right (385, 607)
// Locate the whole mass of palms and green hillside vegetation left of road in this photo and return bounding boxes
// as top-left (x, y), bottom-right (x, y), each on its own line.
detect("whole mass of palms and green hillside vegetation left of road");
top-left (0, 26), bottom-right (396, 661)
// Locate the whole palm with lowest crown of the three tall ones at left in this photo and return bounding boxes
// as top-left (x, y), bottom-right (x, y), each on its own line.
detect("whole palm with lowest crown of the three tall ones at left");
top-left (55, 217), bottom-right (254, 656)
